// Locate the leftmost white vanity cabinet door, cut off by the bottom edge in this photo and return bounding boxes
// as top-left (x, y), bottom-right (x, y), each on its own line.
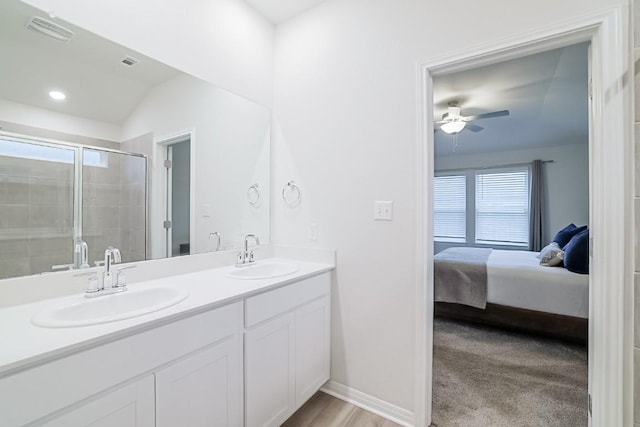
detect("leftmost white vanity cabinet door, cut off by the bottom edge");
top-left (38, 375), bottom-right (155, 427)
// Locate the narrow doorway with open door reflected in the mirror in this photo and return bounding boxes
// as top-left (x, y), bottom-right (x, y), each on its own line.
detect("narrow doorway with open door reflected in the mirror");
top-left (164, 136), bottom-right (191, 257)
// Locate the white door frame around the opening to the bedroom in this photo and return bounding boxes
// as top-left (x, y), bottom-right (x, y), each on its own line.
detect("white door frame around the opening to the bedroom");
top-left (414, 6), bottom-right (634, 427)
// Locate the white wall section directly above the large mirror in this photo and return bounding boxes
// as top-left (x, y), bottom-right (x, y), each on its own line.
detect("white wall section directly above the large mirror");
top-left (24, 0), bottom-right (274, 106)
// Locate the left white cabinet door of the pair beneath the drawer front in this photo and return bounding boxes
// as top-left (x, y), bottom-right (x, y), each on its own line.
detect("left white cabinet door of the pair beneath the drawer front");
top-left (245, 312), bottom-right (295, 427)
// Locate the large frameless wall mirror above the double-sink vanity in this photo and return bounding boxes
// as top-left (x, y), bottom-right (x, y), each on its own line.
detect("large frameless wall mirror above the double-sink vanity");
top-left (0, 0), bottom-right (270, 279)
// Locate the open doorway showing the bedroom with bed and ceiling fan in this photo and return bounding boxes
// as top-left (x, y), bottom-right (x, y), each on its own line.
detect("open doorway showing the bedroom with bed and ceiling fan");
top-left (432, 43), bottom-right (589, 427)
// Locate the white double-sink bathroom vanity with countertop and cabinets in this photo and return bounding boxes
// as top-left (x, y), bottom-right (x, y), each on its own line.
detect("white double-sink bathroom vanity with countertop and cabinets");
top-left (0, 261), bottom-right (333, 427)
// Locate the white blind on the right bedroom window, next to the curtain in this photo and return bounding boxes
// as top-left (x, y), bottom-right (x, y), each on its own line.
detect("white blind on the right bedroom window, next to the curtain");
top-left (475, 168), bottom-right (529, 245)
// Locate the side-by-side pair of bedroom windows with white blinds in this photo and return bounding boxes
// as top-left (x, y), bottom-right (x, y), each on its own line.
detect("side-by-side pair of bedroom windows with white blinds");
top-left (433, 167), bottom-right (530, 246)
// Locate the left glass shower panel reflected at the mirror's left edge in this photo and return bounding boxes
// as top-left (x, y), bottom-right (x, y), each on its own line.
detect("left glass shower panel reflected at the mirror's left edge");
top-left (0, 137), bottom-right (76, 279)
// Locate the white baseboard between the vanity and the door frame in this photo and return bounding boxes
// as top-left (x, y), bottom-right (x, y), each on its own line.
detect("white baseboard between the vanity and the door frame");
top-left (320, 380), bottom-right (414, 427)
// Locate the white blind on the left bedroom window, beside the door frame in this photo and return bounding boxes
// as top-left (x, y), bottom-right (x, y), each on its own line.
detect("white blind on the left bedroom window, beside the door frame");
top-left (433, 175), bottom-right (467, 242)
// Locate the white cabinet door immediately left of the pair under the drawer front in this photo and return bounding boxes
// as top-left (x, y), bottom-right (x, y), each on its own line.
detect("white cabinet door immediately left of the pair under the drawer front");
top-left (155, 334), bottom-right (243, 427)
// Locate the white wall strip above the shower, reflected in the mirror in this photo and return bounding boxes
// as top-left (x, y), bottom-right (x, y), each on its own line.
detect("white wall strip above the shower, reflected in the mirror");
top-left (0, 99), bottom-right (122, 142)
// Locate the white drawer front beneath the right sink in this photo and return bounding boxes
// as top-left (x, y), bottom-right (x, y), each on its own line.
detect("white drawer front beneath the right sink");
top-left (245, 273), bottom-right (331, 327)
